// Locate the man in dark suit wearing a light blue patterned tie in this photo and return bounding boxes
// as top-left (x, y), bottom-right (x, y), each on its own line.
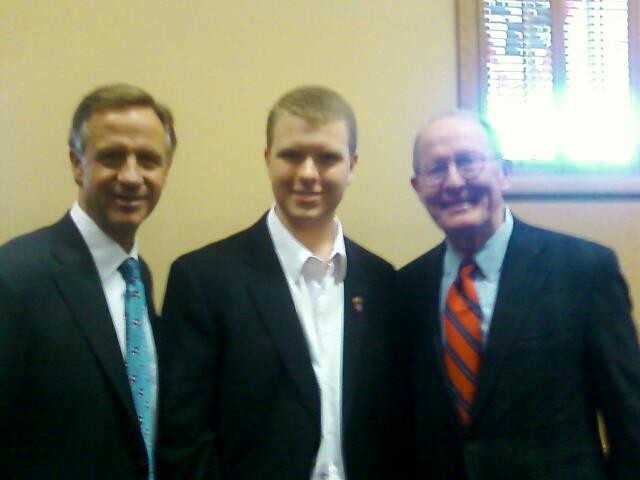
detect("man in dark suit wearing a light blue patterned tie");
top-left (0, 84), bottom-right (176, 480)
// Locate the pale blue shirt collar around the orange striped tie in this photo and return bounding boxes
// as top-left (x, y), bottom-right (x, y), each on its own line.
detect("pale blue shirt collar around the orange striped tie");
top-left (443, 207), bottom-right (513, 282)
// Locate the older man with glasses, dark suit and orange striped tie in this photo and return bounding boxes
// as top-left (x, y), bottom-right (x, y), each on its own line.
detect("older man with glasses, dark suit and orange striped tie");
top-left (399, 112), bottom-right (640, 480)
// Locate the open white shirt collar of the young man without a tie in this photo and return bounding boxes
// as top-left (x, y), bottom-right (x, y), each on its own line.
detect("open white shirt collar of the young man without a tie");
top-left (267, 205), bottom-right (347, 283)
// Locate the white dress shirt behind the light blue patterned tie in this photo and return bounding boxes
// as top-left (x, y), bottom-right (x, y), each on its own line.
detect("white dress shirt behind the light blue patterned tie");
top-left (69, 202), bottom-right (158, 438)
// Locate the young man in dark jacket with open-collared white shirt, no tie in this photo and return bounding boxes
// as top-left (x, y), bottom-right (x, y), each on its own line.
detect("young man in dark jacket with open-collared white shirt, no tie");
top-left (158, 87), bottom-right (400, 480)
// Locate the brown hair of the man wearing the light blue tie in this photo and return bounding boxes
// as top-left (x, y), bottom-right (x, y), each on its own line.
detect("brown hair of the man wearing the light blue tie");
top-left (69, 83), bottom-right (178, 157)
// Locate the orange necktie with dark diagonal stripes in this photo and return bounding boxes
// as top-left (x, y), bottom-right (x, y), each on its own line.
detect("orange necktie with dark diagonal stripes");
top-left (442, 259), bottom-right (482, 426)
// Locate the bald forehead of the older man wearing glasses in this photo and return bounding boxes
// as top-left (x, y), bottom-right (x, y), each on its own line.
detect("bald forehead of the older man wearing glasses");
top-left (418, 116), bottom-right (494, 161)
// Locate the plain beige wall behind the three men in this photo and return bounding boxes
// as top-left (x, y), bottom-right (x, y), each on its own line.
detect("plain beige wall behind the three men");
top-left (0, 0), bottom-right (640, 326)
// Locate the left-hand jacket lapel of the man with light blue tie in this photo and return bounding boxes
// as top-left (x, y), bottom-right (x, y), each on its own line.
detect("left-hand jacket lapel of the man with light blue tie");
top-left (51, 215), bottom-right (137, 424)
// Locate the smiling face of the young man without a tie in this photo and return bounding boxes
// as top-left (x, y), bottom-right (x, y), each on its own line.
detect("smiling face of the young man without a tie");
top-left (265, 111), bottom-right (357, 231)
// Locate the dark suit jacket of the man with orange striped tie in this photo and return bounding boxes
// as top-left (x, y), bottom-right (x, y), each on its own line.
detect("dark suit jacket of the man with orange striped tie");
top-left (399, 220), bottom-right (640, 480)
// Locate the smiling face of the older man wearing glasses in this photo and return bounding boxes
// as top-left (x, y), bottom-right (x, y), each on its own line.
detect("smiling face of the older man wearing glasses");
top-left (411, 115), bottom-right (509, 248)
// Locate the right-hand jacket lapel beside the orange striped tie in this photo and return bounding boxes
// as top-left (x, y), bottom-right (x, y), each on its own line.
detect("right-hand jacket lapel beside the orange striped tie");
top-left (472, 219), bottom-right (546, 418)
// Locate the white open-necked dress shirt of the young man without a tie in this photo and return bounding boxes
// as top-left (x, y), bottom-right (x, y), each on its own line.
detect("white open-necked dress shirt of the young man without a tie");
top-left (267, 208), bottom-right (347, 480)
